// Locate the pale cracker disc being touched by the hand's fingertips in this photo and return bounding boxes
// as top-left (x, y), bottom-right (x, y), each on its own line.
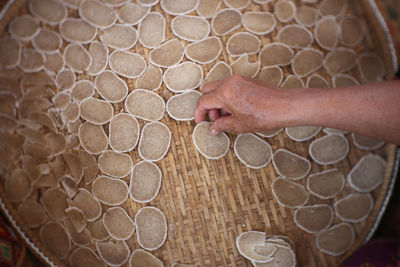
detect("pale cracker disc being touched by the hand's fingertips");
top-left (192, 122), bottom-right (230, 159)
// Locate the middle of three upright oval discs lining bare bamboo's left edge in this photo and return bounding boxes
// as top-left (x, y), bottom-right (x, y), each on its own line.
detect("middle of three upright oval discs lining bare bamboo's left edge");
top-left (130, 161), bottom-right (162, 203)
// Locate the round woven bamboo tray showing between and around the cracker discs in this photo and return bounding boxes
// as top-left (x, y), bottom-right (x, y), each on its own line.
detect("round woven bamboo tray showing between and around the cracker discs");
top-left (0, 0), bottom-right (398, 266)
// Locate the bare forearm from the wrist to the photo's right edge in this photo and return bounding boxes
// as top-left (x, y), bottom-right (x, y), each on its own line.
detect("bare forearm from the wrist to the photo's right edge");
top-left (286, 81), bottom-right (400, 144)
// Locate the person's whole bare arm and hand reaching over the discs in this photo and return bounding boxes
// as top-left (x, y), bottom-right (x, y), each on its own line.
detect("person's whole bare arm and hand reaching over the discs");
top-left (195, 76), bottom-right (400, 144)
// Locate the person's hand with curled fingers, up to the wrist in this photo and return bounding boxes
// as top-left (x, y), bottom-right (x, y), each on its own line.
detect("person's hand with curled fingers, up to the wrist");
top-left (195, 75), bottom-right (289, 135)
